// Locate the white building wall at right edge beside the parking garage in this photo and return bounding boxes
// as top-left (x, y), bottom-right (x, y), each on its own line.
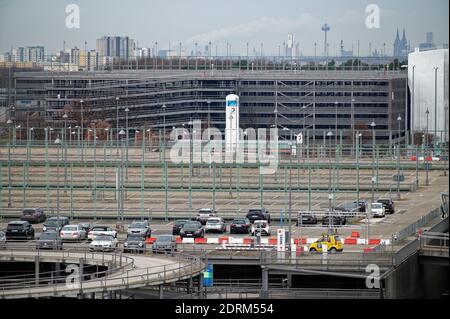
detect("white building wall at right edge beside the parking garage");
top-left (408, 49), bottom-right (449, 141)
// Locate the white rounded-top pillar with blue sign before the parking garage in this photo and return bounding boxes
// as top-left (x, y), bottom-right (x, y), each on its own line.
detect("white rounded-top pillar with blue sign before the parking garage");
top-left (225, 94), bottom-right (239, 160)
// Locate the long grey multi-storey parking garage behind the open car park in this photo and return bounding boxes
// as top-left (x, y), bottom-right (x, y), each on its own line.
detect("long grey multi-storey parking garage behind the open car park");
top-left (12, 70), bottom-right (407, 144)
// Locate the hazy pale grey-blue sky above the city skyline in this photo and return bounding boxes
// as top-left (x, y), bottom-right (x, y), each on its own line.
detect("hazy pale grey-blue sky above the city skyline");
top-left (0, 0), bottom-right (449, 55)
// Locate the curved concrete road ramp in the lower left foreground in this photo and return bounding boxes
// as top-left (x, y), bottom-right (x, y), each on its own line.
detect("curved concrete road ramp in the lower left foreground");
top-left (0, 249), bottom-right (205, 299)
